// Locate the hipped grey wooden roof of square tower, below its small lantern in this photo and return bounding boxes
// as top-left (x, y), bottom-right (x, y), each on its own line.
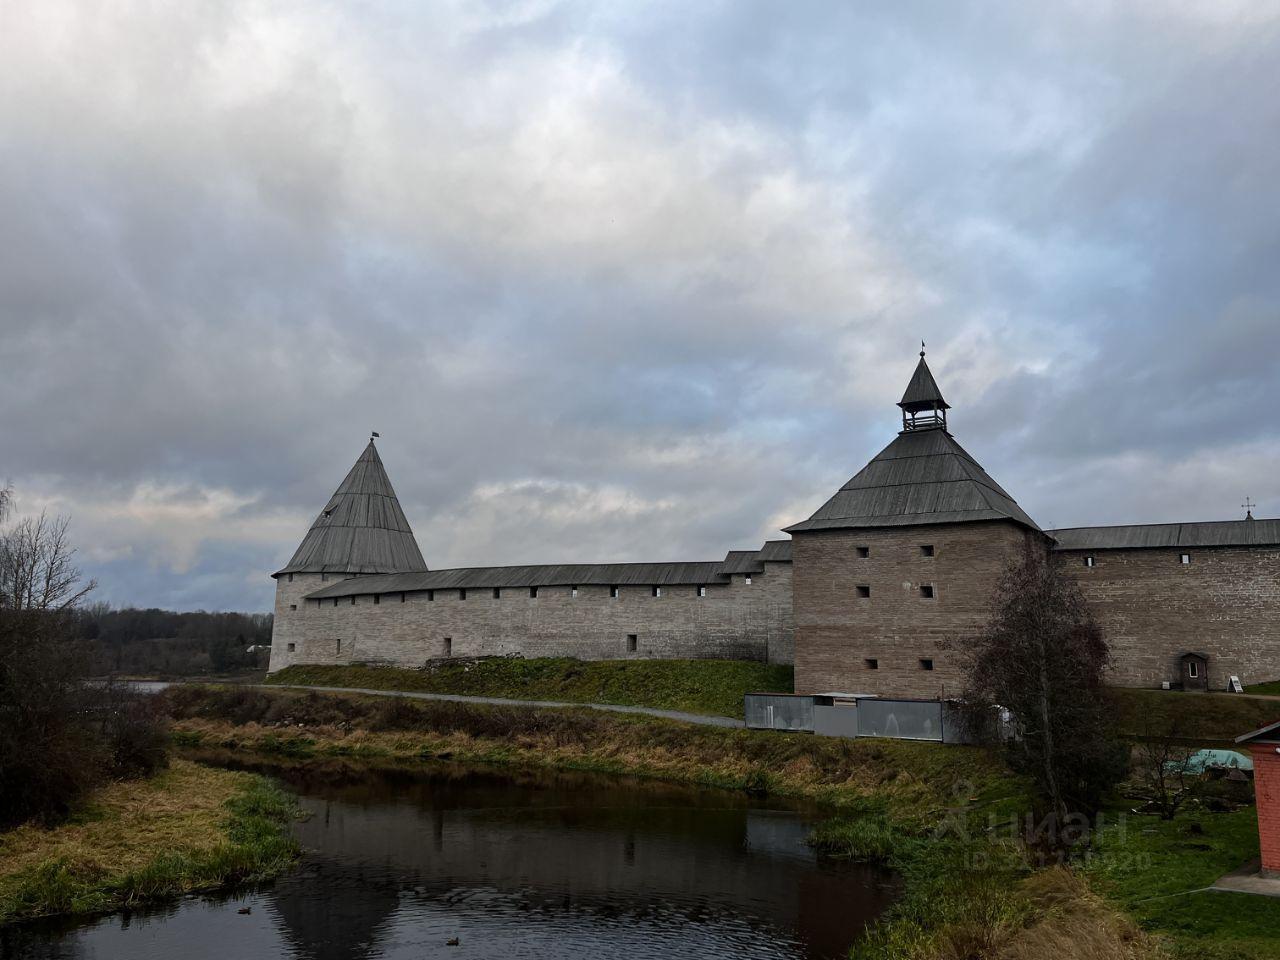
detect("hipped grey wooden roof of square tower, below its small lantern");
top-left (787, 428), bottom-right (1039, 534)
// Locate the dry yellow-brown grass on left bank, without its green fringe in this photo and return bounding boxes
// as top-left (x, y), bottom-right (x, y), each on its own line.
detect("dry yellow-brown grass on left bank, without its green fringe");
top-left (0, 760), bottom-right (239, 892)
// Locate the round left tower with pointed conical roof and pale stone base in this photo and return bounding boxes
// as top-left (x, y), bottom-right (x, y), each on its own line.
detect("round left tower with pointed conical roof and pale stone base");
top-left (270, 439), bottom-right (426, 671)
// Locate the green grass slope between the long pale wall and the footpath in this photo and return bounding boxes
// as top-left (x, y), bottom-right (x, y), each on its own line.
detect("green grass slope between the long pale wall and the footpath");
top-left (268, 657), bottom-right (792, 718)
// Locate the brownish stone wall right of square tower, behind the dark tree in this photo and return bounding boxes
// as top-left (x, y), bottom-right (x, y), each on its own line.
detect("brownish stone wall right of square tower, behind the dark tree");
top-left (1053, 547), bottom-right (1280, 690)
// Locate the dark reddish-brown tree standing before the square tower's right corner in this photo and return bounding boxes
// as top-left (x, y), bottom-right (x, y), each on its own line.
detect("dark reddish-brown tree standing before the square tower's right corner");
top-left (957, 549), bottom-right (1125, 823)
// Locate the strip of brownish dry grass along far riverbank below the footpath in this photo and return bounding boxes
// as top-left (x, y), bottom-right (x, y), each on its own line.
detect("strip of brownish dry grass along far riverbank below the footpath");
top-left (164, 686), bottom-right (1023, 828)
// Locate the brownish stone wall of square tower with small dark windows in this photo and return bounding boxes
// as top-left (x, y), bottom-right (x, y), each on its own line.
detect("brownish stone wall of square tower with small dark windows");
top-left (791, 521), bottom-right (1043, 698)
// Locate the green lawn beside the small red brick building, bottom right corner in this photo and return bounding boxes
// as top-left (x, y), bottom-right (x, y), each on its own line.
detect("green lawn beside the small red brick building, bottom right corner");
top-left (1084, 806), bottom-right (1280, 960)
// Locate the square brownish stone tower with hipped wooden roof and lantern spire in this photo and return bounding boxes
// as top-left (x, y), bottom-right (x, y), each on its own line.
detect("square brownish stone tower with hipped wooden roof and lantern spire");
top-left (787, 348), bottom-right (1048, 698)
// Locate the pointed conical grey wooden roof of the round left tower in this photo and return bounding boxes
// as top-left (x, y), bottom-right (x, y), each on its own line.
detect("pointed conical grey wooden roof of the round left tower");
top-left (275, 440), bottom-right (426, 576)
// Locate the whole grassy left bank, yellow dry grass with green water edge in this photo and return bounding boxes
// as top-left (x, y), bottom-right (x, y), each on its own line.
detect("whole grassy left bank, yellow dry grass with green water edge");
top-left (0, 760), bottom-right (297, 924)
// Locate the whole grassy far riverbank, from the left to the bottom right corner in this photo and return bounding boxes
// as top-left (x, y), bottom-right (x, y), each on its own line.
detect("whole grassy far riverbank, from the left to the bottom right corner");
top-left (165, 687), bottom-right (1280, 960)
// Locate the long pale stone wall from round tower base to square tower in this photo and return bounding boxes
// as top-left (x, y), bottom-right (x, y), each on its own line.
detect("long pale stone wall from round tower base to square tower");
top-left (271, 563), bottom-right (794, 671)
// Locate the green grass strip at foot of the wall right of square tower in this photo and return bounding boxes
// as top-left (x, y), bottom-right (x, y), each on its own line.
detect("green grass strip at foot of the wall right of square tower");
top-left (1111, 687), bottom-right (1280, 742)
